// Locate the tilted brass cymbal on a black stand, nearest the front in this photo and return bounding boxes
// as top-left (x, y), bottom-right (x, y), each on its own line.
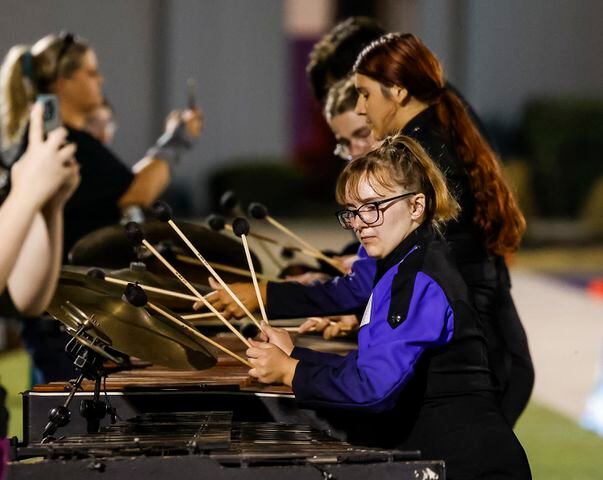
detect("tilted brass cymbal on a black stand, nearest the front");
top-left (48, 271), bottom-right (216, 370)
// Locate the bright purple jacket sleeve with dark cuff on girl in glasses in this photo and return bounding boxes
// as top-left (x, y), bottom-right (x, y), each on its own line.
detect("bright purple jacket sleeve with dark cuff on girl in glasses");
top-left (293, 272), bottom-right (454, 412)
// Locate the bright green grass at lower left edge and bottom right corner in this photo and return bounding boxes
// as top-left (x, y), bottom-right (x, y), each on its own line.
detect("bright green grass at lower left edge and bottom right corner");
top-left (0, 350), bottom-right (603, 480)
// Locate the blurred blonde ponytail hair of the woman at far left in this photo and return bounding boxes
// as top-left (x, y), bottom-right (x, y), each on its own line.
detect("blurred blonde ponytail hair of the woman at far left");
top-left (0, 34), bottom-right (90, 148)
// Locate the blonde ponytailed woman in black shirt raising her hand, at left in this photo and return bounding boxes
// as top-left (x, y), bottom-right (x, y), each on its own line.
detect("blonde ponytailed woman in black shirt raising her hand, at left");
top-left (0, 33), bottom-right (202, 382)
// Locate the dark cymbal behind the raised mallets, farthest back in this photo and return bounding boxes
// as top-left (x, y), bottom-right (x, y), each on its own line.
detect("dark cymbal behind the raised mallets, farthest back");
top-left (69, 221), bottom-right (262, 284)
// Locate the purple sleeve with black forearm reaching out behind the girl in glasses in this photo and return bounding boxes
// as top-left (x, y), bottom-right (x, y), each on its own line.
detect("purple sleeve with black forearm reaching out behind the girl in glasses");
top-left (266, 247), bottom-right (376, 318)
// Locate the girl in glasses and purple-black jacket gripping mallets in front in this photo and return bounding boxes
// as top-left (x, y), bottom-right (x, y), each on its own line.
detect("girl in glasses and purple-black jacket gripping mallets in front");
top-left (247, 136), bottom-right (531, 480)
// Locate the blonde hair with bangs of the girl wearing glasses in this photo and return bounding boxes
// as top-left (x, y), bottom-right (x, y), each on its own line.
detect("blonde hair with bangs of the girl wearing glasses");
top-left (335, 135), bottom-right (460, 230)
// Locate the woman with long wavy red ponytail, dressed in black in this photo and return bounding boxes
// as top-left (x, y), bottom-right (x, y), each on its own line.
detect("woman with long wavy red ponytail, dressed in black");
top-left (354, 34), bottom-right (534, 425)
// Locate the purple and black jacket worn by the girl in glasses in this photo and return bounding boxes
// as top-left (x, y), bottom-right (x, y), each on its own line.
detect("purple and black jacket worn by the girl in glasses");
top-left (292, 226), bottom-right (492, 412)
